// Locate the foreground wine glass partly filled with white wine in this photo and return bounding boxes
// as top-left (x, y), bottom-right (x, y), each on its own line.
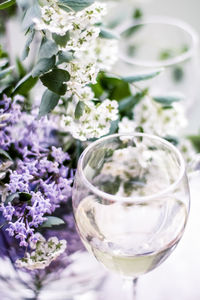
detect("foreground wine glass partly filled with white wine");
top-left (72, 133), bottom-right (190, 299)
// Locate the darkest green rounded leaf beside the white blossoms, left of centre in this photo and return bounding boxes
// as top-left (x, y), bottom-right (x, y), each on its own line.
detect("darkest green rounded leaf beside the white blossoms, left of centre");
top-left (40, 69), bottom-right (70, 96)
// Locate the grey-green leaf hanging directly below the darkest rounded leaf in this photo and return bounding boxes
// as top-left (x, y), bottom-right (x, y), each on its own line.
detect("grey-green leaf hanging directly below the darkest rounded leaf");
top-left (39, 90), bottom-right (60, 118)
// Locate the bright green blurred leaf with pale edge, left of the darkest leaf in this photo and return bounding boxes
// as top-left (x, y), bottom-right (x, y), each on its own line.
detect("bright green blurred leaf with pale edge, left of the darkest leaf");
top-left (13, 73), bottom-right (38, 96)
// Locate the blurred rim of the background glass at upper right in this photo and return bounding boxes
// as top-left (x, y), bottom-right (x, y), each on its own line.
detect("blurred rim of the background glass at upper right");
top-left (117, 16), bottom-right (199, 68)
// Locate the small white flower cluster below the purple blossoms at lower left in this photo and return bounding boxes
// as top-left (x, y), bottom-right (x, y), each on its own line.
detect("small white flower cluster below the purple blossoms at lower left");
top-left (15, 233), bottom-right (67, 270)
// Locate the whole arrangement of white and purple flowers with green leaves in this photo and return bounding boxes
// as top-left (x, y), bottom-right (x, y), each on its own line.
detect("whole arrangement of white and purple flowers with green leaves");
top-left (0, 0), bottom-right (198, 298)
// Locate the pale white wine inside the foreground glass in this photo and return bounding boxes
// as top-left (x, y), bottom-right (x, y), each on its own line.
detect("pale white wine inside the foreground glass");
top-left (75, 196), bottom-right (187, 278)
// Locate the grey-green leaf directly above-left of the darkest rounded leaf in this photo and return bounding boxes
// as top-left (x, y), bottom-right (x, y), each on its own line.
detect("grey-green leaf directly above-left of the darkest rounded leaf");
top-left (32, 55), bottom-right (56, 77)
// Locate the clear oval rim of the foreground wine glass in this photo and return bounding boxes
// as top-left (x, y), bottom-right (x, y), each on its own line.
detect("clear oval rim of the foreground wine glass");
top-left (77, 133), bottom-right (186, 203)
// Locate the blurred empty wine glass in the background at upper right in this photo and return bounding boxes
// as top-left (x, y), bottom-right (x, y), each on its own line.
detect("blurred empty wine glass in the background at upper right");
top-left (114, 16), bottom-right (199, 111)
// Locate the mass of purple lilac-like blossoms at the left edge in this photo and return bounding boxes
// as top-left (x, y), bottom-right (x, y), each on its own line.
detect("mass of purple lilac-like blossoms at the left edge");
top-left (0, 97), bottom-right (73, 251)
